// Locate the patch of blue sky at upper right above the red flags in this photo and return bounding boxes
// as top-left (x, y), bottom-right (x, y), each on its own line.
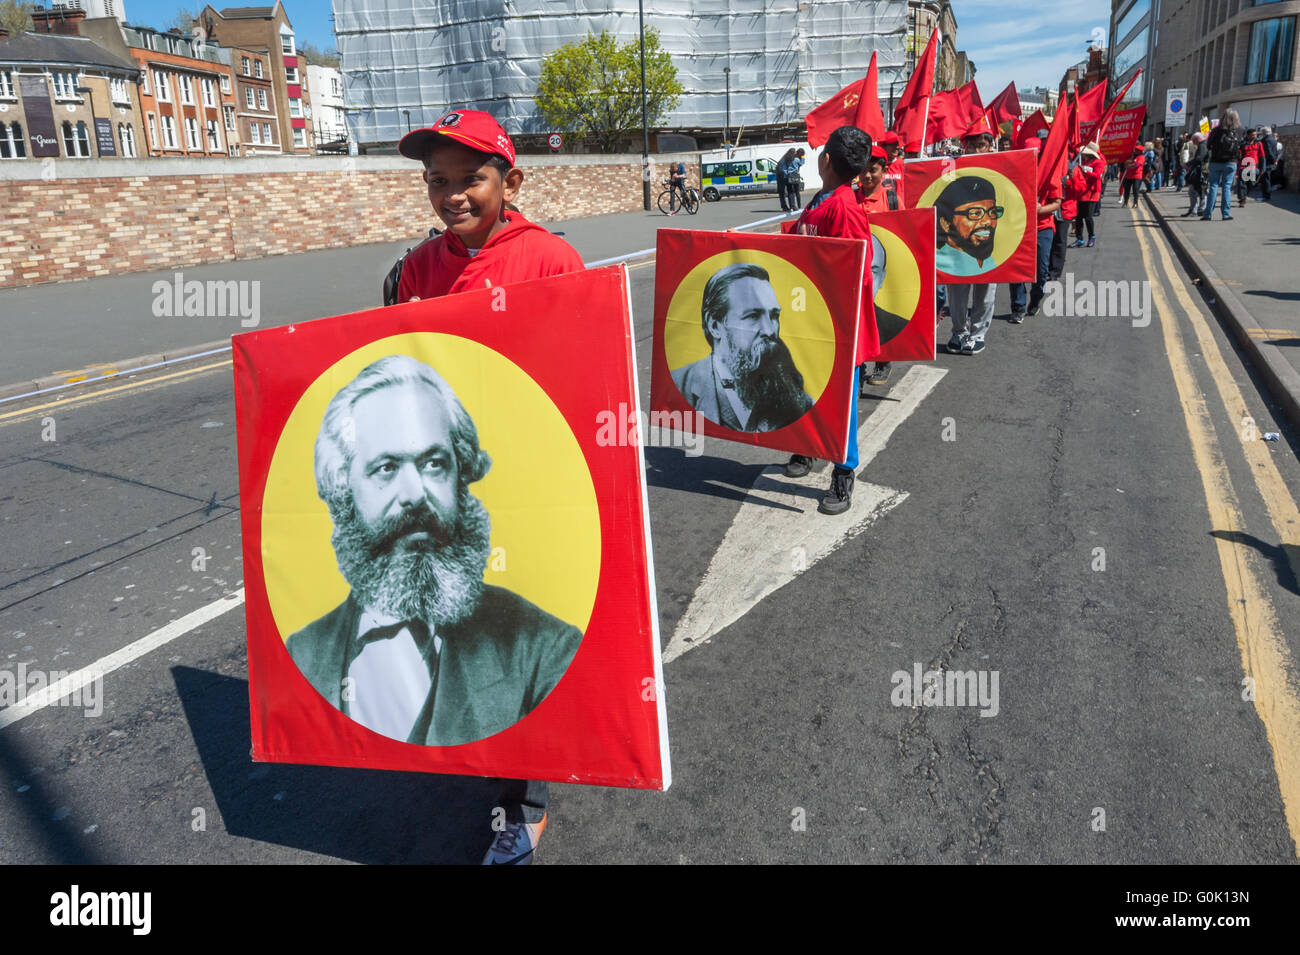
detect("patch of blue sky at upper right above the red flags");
top-left (953, 0), bottom-right (1110, 95)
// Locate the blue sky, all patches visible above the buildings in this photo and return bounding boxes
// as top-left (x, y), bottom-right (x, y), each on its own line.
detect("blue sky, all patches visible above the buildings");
top-left (126, 0), bottom-right (1110, 99)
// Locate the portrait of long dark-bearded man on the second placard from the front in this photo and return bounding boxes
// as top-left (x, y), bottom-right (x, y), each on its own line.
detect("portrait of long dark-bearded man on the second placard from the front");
top-left (672, 262), bottom-right (813, 431)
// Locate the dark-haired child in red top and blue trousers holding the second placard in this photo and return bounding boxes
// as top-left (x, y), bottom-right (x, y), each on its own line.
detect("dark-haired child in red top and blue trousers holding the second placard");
top-left (785, 126), bottom-right (880, 515)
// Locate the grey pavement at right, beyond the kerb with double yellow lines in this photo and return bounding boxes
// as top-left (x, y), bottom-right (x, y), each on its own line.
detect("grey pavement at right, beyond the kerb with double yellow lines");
top-left (1147, 190), bottom-right (1300, 430)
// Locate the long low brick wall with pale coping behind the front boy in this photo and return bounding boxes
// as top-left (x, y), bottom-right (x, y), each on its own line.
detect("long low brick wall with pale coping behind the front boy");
top-left (0, 156), bottom-right (699, 288)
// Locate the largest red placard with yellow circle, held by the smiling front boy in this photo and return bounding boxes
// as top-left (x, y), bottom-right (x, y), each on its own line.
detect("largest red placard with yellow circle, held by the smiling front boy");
top-left (234, 266), bottom-right (670, 789)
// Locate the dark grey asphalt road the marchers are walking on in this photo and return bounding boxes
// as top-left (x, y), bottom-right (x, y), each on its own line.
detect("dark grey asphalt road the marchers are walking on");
top-left (0, 197), bottom-right (1300, 863)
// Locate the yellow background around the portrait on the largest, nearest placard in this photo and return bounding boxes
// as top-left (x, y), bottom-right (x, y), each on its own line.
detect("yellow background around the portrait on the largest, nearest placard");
top-left (261, 333), bottom-right (601, 639)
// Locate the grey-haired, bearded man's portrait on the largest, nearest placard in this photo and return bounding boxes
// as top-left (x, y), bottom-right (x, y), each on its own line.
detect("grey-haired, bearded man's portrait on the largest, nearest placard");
top-left (287, 355), bottom-right (582, 746)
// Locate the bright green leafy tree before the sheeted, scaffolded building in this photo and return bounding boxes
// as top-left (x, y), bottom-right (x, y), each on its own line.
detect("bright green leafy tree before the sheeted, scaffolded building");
top-left (536, 27), bottom-right (685, 152)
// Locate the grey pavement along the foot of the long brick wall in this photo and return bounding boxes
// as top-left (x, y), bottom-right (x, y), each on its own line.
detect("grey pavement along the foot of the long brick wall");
top-left (0, 191), bottom-right (800, 399)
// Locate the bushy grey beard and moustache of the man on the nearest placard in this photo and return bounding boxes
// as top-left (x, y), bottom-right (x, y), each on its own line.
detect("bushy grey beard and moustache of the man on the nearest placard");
top-left (330, 487), bottom-right (491, 630)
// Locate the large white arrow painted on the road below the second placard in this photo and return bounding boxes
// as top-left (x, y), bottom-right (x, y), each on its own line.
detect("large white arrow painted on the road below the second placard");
top-left (663, 365), bottom-right (948, 663)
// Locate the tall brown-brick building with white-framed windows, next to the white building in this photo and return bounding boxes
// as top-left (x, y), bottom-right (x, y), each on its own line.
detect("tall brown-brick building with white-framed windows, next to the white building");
top-left (195, 0), bottom-right (313, 153)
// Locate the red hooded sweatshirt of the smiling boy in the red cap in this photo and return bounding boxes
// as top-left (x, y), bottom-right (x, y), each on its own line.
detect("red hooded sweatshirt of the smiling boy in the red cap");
top-left (398, 210), bottom-right (585, 303)
